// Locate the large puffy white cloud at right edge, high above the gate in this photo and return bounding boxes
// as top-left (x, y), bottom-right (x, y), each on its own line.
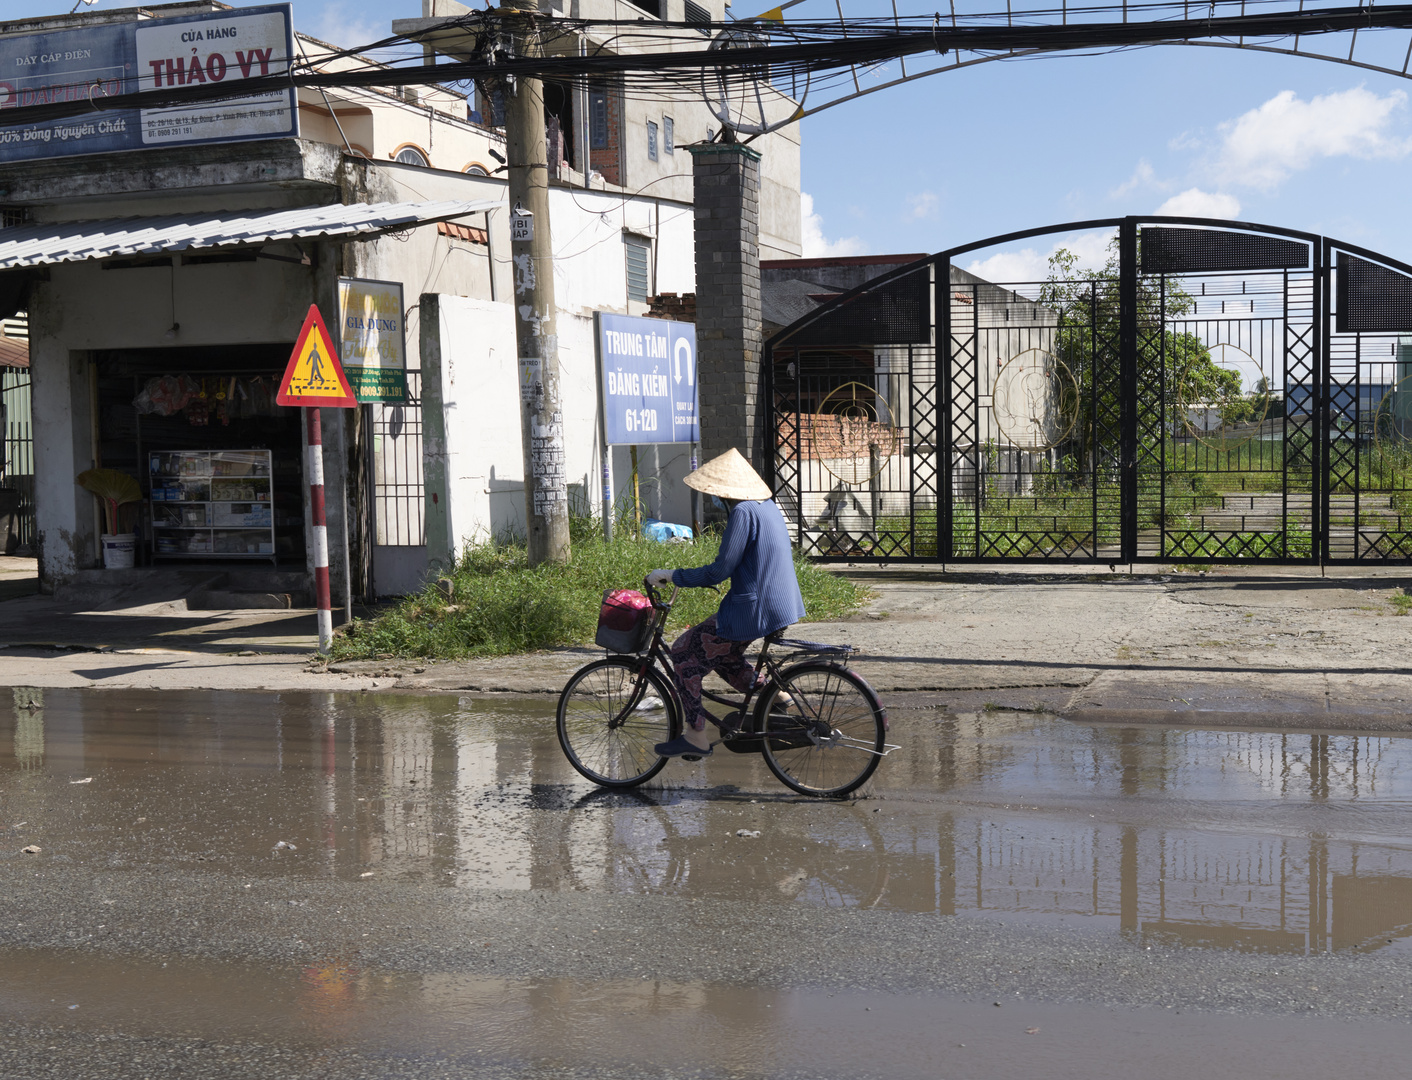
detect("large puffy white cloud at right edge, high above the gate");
top-left (1213, 86), bottom-right (1412, 191)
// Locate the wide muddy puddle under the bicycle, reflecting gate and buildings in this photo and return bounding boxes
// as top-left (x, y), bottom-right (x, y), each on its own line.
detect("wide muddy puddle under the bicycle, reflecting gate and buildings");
top-left (0, 690), bottom-right (1412, 954)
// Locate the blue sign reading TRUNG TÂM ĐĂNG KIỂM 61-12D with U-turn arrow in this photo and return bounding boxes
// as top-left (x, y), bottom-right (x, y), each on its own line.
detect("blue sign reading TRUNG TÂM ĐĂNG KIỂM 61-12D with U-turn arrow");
top-left (597, 312), bottom-right (700, 446)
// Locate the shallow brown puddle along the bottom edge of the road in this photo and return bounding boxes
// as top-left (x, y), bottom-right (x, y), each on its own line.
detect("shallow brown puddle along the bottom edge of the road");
top-left (0, 950), bottom-right (1406, 1080)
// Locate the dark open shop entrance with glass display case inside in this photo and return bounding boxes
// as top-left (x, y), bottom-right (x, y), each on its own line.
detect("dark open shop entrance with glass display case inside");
top-left (99, 343), bottom-right (305, 568)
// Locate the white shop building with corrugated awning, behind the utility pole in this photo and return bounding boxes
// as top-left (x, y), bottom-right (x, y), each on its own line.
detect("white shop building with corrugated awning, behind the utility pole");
top-left (0, 0), bottom-right (796, 604)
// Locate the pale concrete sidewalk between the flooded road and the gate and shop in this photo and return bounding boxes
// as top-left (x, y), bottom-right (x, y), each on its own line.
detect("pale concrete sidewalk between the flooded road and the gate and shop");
top-left (8, 566), bottom-right (1412, 730)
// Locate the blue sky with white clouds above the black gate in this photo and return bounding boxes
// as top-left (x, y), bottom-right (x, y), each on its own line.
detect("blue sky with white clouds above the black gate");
top-left (11, 0), bottom-right (1412, 281)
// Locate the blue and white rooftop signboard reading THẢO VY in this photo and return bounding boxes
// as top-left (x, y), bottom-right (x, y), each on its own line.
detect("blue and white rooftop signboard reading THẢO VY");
top-left (0, 4), bottom-right (299, 161)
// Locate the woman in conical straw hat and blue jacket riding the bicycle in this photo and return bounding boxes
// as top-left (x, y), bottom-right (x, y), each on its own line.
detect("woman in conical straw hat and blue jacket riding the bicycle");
top-left (647, 449), bottom-right (805, 758)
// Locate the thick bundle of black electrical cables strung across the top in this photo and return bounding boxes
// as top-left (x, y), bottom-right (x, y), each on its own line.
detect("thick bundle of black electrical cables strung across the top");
top-left (4, 0), bottom-right (1412, 127)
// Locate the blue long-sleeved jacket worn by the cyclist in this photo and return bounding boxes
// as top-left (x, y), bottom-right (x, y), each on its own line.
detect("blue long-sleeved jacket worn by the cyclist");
top-left (672, 498), bottom-right (803, 641)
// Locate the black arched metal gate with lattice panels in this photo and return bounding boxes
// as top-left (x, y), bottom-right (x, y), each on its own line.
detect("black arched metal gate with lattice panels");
top-left (764, 217), bottom-right (1412, 563)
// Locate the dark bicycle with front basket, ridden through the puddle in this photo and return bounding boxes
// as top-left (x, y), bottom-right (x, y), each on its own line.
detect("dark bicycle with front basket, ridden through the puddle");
top-left (555, 582), bottom-right (898, 798)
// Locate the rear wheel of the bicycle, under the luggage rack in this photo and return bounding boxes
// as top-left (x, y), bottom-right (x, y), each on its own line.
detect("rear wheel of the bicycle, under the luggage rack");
top-left (755, 661), bottom-right (887, 798)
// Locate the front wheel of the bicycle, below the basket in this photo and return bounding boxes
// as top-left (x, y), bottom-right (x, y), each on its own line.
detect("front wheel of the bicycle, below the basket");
top-left (555, 656), bottom-right (682, 788)
